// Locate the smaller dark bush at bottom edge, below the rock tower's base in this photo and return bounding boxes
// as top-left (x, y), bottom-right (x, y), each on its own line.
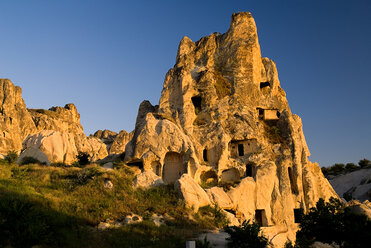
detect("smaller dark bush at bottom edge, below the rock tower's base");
top-left (224, 221), bottom-right (269, 248)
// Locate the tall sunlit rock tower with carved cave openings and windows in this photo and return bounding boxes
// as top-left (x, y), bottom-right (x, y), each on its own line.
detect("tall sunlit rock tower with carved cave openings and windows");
top-left (125, 13), bottom-right (337, 246)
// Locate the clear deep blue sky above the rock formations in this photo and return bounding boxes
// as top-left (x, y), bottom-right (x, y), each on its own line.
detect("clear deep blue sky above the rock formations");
top-left (0, 0), bottom-right (371, 166)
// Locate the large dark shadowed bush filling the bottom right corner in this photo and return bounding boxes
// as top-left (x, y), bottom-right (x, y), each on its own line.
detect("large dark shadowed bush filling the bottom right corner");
top-left (295, 198), bottom-right (371, 248)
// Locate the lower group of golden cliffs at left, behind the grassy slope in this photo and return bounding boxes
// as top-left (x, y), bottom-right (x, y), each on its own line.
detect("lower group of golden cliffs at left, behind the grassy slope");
top-left (0, 79), bottom-right (108, 163)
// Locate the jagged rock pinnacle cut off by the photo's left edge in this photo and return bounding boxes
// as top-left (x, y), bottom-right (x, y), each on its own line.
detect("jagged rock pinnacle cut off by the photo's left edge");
top-left (0, 79), bottom-right (36, 154)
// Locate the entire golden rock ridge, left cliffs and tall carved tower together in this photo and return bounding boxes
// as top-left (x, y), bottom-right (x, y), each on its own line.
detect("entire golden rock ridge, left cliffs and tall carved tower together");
top-left (0, 12), bottom-right (344, 247)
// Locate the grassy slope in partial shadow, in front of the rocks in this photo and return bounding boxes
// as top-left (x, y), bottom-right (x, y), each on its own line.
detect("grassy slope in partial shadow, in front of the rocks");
top-left (0, 161), bottom-right (224, 247)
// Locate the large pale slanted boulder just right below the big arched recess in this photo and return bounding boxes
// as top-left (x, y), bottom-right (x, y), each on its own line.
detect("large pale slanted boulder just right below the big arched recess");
top-left (174, 174), bottom-right (211, 212)
